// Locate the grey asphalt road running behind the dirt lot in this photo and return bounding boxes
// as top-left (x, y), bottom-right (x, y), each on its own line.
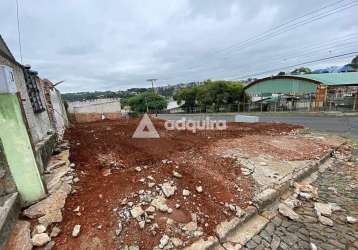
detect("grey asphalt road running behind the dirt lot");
top-left (159, 114), bottom-right (358, 138)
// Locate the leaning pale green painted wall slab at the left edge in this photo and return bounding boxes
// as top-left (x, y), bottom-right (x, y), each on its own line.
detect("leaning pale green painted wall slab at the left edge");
top-left (0, 93), bottom-right (46, 203)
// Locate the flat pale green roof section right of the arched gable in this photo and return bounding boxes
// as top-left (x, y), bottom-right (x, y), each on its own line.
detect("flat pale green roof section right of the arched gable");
top-left (288, 72), bottom-right (358, 86)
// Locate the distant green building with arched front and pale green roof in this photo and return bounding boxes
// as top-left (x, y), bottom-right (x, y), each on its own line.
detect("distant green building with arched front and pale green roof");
top-left (244, 72), bottom-right (358, 111)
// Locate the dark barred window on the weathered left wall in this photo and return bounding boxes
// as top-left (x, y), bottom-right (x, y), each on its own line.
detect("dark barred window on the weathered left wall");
top-left (24, 68), bottom-right (45, 113)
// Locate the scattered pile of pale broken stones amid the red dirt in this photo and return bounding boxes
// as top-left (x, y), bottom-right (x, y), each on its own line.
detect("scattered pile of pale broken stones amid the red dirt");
top-left (113, 167), bottom-right (243, 249)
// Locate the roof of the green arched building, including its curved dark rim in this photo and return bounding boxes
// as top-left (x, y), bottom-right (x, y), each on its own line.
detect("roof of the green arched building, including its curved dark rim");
top-left (244, 72), bottom-right (358, 89)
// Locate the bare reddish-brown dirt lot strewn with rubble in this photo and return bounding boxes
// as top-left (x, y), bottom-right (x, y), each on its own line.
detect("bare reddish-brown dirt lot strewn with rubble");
top-left (55, 119), bottom-right (316, 249)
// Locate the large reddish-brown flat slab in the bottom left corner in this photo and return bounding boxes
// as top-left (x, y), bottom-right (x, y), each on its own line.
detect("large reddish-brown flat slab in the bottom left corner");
top-left (7, 220), bottom-right (32, 250)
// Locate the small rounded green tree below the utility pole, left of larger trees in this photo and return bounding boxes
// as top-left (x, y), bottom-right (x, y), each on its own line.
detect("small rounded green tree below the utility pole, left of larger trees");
top-left (128, 91), bottom-right (168, 113)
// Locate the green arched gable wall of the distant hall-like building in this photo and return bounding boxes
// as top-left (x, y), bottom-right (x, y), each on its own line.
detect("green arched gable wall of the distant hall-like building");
top-left (245, 79), bottom-right (317, 95)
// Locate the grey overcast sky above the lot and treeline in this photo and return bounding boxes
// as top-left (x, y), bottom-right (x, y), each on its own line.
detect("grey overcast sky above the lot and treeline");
top-left (0, 0), bottom-right (358, 92)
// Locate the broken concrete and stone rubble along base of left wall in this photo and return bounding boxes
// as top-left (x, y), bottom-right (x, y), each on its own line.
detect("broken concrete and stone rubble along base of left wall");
top-left (6, 142), bottom-right (79, 249)
